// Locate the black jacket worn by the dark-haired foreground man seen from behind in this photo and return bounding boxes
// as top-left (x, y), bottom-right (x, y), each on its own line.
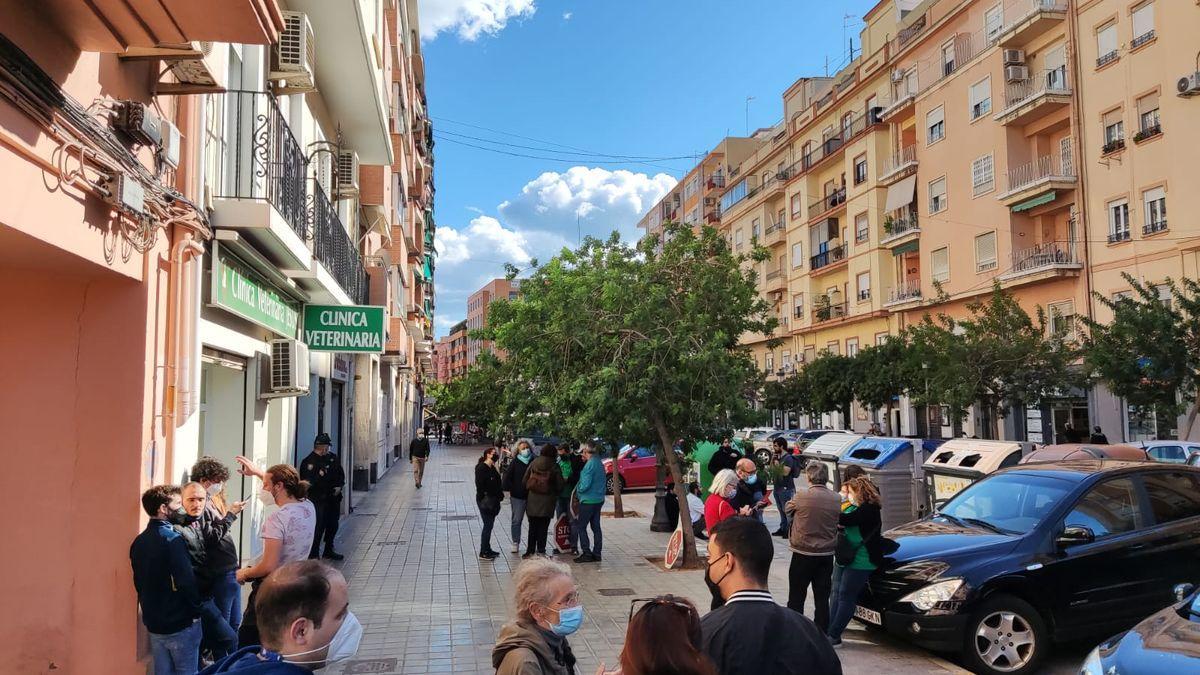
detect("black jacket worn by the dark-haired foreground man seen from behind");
top-left (700, 591), bottom-right (841, 675)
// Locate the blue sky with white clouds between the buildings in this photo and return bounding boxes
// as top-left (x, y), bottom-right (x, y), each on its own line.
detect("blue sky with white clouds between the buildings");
top-left (419, 0), bottom-right (875, 336)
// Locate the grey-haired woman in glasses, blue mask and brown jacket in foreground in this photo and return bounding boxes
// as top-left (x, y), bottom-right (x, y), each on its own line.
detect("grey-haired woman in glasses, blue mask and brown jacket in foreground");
top-left (492, 557), bottom-right (583, 675)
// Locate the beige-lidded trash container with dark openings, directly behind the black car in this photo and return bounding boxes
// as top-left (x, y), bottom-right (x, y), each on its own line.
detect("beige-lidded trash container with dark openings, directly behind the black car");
top-left (922, 438), bottom-right (1033, 510)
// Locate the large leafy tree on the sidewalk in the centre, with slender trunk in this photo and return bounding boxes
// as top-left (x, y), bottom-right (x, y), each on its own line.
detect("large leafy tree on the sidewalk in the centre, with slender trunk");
top-left (486, 223), bottom-right (775, 567)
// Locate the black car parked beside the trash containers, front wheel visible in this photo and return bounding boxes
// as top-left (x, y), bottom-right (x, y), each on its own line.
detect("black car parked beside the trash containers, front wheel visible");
top-left (854, 460), bottom-right (1200, 674)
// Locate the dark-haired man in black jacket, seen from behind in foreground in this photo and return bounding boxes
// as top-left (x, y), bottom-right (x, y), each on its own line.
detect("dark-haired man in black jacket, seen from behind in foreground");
top-left (700, 516), bottom-right (841, 675)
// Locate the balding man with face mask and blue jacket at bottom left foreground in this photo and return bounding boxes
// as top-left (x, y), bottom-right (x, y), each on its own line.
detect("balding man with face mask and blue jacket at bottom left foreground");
top-left (202, 560), bottom-right (362, 675)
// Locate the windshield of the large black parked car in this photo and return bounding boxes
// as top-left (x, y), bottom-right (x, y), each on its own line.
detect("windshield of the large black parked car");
top-left (938, 473), bottom-right (1072, 534)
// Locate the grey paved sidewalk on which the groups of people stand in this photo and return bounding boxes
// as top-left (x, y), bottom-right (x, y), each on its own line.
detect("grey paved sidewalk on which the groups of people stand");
top-left (329, 446), bottom-right (964, 675)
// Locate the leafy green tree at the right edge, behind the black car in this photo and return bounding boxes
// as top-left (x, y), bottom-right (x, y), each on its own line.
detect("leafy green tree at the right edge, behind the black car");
top-left (1084, 274), bottom-right (1200, 438)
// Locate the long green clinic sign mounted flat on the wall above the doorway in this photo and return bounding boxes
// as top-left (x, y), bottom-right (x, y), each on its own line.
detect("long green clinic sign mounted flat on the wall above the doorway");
top-left (212, 246), bottom-right (300, 338)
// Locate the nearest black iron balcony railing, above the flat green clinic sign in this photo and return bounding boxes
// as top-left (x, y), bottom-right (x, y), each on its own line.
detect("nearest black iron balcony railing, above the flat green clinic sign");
top-left (216, 90), bottom-right (308, 238)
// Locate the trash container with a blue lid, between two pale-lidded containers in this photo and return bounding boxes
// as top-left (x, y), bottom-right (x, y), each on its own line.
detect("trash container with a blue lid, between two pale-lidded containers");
top-left (840, 436), bottom-right (929, 530)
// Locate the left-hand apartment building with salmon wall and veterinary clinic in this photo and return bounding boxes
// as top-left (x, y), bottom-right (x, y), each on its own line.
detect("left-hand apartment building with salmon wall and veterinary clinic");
top-left (0, 0), bottom-right (433, 673)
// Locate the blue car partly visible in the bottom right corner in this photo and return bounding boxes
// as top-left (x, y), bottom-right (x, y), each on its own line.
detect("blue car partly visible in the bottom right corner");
top-left (1079, 584), bottom-right (1200, 675)
